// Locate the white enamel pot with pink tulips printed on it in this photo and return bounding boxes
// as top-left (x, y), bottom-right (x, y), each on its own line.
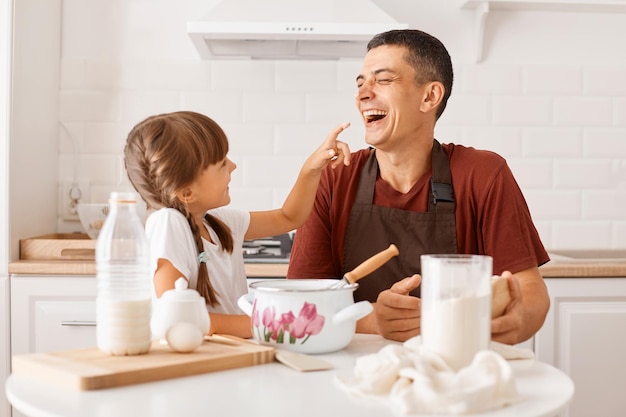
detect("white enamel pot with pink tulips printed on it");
top-left (238, 279), bottom-right (373, 353)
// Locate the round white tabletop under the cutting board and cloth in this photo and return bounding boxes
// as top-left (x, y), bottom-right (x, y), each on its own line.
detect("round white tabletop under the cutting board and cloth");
top-left (6, 334), bottom-right (574, 417)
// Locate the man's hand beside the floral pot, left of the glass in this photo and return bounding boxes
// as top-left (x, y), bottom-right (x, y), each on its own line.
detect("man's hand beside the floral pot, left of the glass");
top-left (373, 274), bottom-right (422, 342)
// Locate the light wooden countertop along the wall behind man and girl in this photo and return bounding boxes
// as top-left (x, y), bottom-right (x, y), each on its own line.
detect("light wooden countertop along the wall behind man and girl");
top-left (9, 250), bottom-right (626, 278)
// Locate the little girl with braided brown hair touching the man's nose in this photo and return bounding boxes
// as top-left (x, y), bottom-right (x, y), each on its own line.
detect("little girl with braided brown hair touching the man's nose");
top-left (124, 111), bottom-right (350, 337)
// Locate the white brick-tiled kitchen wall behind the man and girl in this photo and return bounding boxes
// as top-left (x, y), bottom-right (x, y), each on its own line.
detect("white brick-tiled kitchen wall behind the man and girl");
top-left (54, 0), bottom-right (626, 248)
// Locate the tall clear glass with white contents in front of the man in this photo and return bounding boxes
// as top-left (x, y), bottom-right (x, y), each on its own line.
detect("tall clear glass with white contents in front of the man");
top-left (421, 255), bottom-right (492, 371)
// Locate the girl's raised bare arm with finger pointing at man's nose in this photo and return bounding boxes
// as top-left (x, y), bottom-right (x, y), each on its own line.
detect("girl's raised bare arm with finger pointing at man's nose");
top-left (245, 123), bottom-right (350, 239)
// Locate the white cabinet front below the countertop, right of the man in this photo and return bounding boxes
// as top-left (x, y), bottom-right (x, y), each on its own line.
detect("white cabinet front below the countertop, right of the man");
top-left (535, 278), bottom-right (626, 417)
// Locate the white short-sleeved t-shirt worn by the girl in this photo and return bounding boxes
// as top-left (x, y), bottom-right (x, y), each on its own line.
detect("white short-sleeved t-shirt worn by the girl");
top-left (146, 207), bottom-right (250, 314)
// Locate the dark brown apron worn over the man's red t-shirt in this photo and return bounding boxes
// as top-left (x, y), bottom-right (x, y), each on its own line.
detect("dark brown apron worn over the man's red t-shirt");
top-left (342, 140), bottom-right (457, 302)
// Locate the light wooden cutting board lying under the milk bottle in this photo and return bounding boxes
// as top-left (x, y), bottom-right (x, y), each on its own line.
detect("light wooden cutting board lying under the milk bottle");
top-left (12, 341), bottom-right (275, 390)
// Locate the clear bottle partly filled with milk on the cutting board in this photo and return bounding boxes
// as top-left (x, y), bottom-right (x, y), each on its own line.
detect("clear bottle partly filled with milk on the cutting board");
top-left (96, 192), bottom-right (152, 355)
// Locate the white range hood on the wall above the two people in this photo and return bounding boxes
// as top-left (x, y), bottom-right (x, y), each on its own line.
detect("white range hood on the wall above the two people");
top-left (187, 0), bottom-right (408, 59)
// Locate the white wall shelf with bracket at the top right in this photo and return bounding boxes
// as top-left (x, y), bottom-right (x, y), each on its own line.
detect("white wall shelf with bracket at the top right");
top-left (461, 0), bottom-right (626, 62)
